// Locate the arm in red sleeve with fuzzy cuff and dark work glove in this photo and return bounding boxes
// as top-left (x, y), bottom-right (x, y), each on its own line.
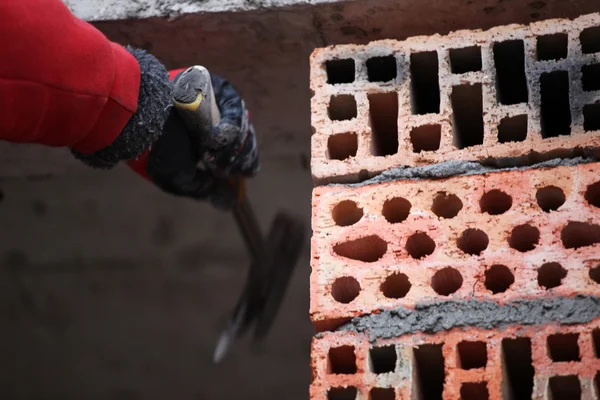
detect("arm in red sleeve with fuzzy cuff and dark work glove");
top-left (0, 0), bottom-right (258, 211)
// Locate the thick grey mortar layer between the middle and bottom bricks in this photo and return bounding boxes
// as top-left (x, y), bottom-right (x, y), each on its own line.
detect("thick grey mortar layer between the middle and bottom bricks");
top-left (336, 295), bottom-right (600, 342)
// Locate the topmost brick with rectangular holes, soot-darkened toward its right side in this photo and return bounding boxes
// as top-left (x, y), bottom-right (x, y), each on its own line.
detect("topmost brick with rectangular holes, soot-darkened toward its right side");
top-left (311, 14), bottom-right (600, 184)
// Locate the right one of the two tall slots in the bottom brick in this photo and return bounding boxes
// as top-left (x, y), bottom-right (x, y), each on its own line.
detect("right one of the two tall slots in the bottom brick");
top-left (502, 337), bottom-right (535, 399)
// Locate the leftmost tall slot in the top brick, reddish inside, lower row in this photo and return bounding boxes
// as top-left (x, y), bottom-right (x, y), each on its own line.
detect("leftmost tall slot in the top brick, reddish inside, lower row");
top-left (368, 92), bottom-right (398, 157)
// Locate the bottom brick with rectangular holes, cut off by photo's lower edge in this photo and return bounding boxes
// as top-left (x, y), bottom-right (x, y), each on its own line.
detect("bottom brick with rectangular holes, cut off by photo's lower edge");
top-left (310, 320), bottom-right (600, 400)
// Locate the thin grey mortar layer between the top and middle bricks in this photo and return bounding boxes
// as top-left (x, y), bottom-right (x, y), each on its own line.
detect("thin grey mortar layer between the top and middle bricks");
top-left (328, 157), bottom-right (597, 188)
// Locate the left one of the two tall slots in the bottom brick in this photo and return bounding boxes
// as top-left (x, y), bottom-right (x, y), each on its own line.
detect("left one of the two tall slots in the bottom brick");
top-left (413, 344), bottom-right (445, 400)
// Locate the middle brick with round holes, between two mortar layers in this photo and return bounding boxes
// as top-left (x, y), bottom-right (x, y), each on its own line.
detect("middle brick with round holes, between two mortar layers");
top-left (310, 163), bottom-right (600, 331)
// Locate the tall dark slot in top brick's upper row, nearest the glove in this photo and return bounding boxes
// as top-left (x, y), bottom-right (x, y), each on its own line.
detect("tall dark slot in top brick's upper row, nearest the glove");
top-left (410, 51), bottom-right (440, 115)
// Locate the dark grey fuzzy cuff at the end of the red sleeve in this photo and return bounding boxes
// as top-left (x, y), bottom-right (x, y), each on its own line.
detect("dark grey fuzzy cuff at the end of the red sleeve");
top-left (71, 46), bottom-right (173, 169)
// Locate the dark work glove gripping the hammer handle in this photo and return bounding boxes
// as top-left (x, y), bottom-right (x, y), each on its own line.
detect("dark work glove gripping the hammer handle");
top-left (130, 64), bottom-right (260, 210)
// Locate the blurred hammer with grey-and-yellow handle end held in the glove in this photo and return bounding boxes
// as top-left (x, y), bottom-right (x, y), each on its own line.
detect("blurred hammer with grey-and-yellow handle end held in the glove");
top-left (173, 65), bottom-right (305, 363)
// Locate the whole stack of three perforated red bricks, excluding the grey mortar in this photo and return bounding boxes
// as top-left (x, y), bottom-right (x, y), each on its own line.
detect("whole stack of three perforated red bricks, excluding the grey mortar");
top-left (310, 10), bottom-right (600, 400)
